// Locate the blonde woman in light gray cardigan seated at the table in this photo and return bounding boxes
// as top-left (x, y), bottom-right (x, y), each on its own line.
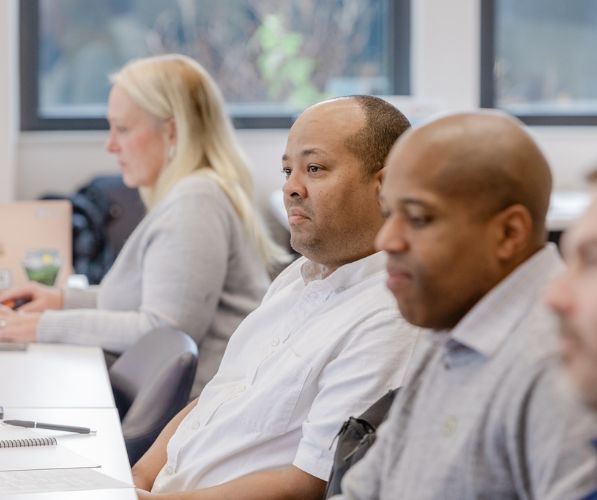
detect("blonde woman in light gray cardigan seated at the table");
top-left (0, 55), bottom-right (284, 396)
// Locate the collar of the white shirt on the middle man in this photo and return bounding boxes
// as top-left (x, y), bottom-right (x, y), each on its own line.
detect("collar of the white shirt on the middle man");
top-left (300, 252), bottom-right (387, 292)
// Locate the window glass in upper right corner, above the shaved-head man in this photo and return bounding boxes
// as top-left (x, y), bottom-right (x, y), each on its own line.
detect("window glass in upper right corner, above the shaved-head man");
top-left (492, 0), bottom-right (597, 115)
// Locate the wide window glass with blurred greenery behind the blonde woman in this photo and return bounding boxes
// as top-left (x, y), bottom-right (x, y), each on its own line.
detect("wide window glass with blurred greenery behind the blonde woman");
top-left (35, 0), bottom-right (401, 125)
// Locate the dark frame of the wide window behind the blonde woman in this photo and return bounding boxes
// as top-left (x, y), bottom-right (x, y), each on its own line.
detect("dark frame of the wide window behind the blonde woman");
top-left (19, 0), bottom-right (411, 131)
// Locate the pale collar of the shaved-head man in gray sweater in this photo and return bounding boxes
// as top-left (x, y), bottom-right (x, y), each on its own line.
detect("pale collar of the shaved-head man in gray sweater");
top-left (447, 243), bottom-right (563, 357)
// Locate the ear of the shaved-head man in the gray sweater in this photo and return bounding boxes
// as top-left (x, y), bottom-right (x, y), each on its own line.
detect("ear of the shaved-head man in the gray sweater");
top-left (493, 204), bottom-right (533, 261)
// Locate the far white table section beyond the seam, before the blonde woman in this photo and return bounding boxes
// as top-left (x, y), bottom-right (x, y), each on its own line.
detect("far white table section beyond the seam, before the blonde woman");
top-left (0, 344), bottom-right (114, 408)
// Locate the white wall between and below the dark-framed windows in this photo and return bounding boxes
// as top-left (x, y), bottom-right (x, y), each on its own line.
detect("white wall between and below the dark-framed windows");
top-left (0, 0), bottom-right (597, 204)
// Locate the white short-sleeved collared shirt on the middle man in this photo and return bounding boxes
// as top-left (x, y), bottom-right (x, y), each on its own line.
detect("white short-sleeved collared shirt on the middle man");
top-left (152, 253), bottom-right (418, 493)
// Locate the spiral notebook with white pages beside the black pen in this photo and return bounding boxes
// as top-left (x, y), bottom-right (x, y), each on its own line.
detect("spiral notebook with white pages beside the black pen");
top-left (0, 422), bottom-right (99, 471)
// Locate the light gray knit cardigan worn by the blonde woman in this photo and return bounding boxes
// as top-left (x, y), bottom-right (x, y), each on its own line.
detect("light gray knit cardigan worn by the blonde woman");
top-left (37, 176), bottom-right (269, 396)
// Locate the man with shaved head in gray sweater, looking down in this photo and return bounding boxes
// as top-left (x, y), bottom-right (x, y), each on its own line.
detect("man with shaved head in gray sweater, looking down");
top-left (333, 112), bottom-right (597, 500)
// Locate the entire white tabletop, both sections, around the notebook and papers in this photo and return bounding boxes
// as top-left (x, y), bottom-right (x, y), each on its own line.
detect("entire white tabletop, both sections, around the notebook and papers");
top-left (0, 344), bottom-right (137, 500)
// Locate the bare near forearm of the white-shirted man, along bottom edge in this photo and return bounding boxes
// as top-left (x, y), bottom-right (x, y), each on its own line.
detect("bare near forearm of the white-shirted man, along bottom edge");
top-left (147, 466), bottom-right (326, 500)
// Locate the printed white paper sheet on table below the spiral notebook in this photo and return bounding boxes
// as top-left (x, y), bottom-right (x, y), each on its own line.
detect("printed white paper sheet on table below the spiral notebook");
top-left (0, 468), bottom-right (133, 496)
